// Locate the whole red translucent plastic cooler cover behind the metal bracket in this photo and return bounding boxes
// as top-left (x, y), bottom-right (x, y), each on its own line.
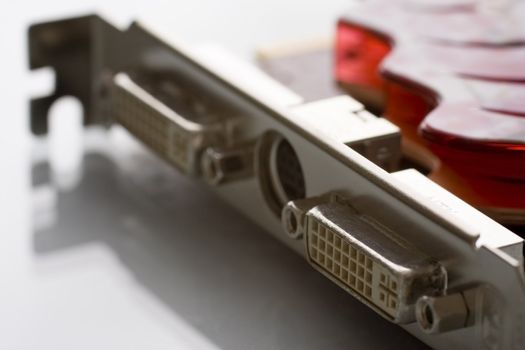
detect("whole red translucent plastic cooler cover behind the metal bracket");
top-left (335, 20), bottom-right (525, 217)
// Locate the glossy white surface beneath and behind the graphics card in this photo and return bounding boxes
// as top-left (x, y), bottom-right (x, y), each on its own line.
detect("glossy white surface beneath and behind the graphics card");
top-left (0, 0), bottom-right (423, 350)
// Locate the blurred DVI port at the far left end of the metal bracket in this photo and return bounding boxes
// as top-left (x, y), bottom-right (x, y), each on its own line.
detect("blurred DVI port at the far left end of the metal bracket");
top-left (111, 73), bottom-right (235, 175)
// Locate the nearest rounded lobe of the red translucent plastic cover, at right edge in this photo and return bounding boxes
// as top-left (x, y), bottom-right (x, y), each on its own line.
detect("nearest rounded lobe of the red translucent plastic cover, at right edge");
top-left (421, 103), bottom-right (525, 179)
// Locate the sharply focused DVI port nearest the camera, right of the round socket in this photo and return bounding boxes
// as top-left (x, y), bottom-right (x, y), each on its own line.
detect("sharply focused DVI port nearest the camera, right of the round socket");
top-left (283, 194), bottom-right (447, 323)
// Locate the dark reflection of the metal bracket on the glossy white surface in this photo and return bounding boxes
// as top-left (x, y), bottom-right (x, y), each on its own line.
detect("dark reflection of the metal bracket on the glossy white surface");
top-left (33, 129), bottom-right (422, 349)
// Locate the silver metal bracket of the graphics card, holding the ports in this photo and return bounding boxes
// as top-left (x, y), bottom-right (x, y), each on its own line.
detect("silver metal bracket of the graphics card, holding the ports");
top-left (29, 16), bottom-right (525, 349)
